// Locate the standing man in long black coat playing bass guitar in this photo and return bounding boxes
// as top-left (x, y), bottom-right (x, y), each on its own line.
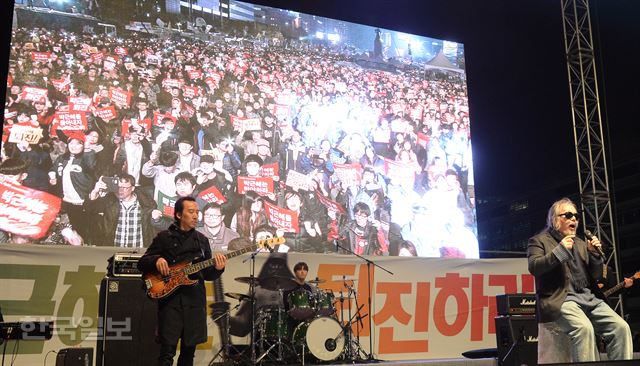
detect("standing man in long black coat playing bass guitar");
top-left (138, 197), bottom-right (227, 366)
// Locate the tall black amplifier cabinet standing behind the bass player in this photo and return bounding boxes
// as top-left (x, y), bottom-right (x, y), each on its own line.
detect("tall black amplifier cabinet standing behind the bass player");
top-left (96, 277), bottom-right (160, 366)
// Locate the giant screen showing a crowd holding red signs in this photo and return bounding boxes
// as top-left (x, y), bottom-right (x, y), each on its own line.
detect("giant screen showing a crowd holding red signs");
top-left (0, 0), bottom-right (479, 258)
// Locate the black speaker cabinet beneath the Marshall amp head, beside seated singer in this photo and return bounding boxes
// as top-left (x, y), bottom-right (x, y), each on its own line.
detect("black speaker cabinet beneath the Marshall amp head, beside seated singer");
top-left (495, 315), bottom-right (538, 366)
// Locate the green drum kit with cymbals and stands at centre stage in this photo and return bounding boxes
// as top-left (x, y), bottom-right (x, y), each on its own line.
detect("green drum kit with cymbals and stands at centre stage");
top-left (212, 276), bottom-right (368, 365)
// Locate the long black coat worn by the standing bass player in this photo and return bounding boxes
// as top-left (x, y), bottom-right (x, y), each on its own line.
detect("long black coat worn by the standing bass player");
top-left (138, 224), bottom-right (224, 346)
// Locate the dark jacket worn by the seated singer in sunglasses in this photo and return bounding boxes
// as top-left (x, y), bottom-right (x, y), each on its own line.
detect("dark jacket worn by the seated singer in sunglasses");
top-left (527, 230), bottom-right (602, 323)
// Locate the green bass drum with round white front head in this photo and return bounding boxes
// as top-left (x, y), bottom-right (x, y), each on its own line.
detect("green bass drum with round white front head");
top-left (293, 316), bottom-right (344, 363)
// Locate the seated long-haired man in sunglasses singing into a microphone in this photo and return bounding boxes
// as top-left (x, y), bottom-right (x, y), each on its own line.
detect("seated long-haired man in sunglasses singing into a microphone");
top-left (527, 198), bottom-right (633, 362)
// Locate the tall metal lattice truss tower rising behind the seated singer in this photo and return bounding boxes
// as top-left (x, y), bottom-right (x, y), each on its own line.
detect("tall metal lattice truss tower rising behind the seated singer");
top-left (561, 0), bottom-right (624, 315)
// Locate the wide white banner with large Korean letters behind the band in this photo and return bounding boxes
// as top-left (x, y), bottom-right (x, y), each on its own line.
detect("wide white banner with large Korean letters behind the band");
top-left (0, 244), bottom-right (534, 365)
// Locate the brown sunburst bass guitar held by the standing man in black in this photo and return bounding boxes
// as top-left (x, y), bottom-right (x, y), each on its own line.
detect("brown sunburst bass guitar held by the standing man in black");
top-left (142, 238), bottom-right (285, 299)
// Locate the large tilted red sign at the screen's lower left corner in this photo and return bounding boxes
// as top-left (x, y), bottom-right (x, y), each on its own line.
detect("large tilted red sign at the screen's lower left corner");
top-left (0, 180), bottom-right (62, 239)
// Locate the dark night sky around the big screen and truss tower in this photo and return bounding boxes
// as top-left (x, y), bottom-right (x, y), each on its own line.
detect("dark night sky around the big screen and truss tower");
top-left (0, 0), bottom-right (640, 197)
